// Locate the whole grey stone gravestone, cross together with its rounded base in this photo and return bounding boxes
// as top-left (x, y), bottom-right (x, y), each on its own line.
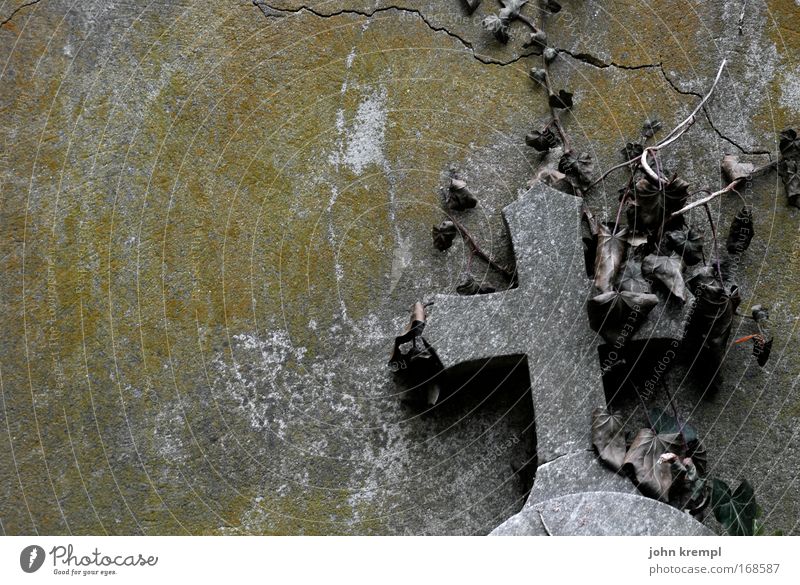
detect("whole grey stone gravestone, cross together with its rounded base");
top-left (425, 183), bottom-right (707, 535)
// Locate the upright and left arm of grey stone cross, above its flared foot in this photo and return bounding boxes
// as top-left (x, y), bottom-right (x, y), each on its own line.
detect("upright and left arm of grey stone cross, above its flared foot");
top-left (425, 183), bottom-right (605, 464)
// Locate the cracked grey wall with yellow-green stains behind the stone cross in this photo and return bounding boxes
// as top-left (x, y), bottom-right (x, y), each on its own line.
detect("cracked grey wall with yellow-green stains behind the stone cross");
top-left (0, 0), bottom-right (800, 534)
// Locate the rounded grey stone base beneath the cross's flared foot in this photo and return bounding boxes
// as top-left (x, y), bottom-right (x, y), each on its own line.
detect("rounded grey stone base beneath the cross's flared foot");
top-left (492, 492), bottom-right (713, 536)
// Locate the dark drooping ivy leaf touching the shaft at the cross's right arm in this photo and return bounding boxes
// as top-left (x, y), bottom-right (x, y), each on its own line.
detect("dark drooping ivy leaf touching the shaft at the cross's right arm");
top-left (586, 290), bottom-right (658, 343)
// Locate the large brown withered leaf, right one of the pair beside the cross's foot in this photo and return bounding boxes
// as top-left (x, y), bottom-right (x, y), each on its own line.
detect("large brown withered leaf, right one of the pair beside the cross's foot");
top-left (623, 429), bottom-right (686, 502)
